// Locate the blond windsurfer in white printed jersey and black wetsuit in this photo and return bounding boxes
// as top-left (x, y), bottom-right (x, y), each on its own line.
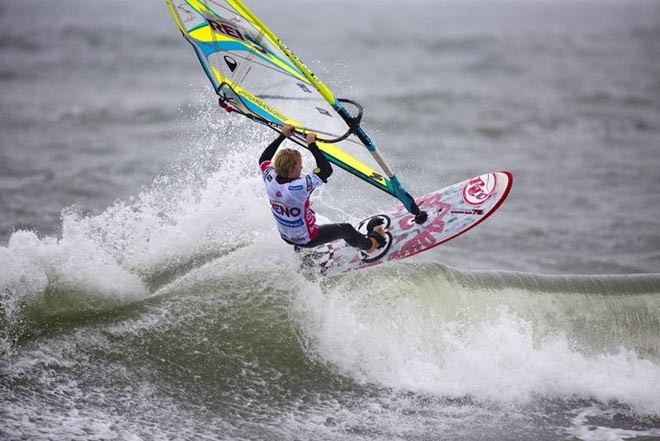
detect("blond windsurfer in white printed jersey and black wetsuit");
top-left (259, 124), bottom-right (386, 253)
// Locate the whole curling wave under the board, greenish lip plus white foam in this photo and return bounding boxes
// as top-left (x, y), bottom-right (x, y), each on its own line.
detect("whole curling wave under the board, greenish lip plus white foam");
top-left (296, 264), bottom-right (660, 415)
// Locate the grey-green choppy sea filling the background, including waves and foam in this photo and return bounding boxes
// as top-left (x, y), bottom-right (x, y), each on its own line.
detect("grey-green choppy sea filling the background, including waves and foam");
top-left (0, 0), bottom-right (660, 440)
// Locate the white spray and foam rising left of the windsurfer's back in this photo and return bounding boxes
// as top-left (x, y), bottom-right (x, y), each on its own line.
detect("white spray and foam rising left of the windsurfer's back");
top-left (0, 117), bottom-right (296, 324)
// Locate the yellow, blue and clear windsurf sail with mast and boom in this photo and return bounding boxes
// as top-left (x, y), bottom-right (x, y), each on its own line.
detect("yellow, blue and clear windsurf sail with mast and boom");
top-left (166, 0), bottom-right (426, 222)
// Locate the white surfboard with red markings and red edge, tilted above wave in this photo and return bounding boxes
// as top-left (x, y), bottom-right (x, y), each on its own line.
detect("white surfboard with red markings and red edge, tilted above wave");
top-left (297, 171), bottom-right (513, 277)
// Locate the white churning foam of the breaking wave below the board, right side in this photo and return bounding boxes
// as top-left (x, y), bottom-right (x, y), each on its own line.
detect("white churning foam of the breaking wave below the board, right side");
top-left (298, 271), bottom-right (660, 415)
